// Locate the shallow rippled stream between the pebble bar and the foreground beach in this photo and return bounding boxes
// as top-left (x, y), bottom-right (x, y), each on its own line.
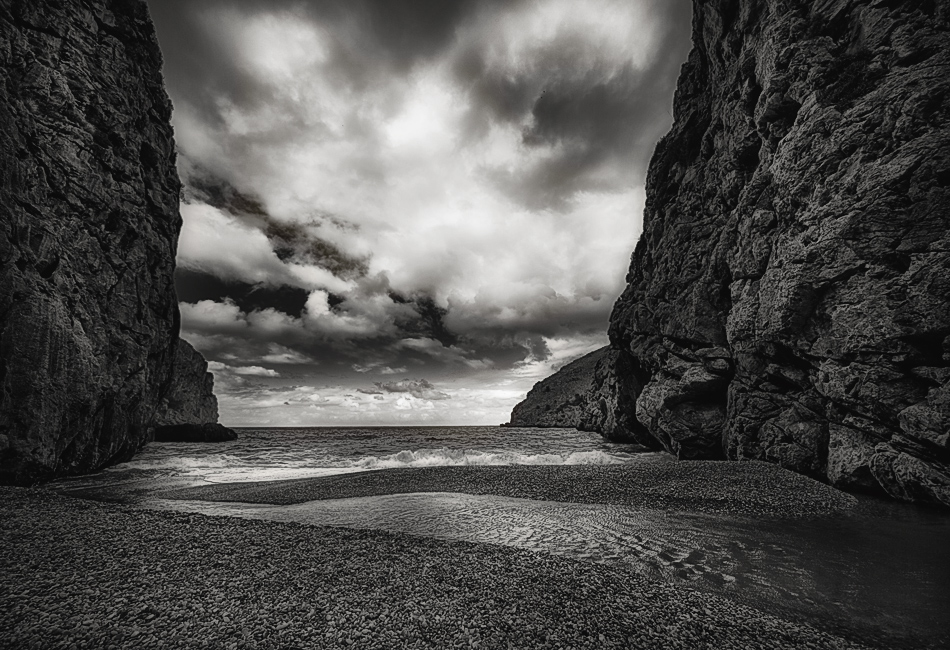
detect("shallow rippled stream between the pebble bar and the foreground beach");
top-left (146, 493), bottom-right (950, 647)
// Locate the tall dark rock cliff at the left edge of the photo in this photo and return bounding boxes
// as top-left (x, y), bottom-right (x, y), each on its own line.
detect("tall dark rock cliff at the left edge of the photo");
top-left (0, 0), bottom-right (181, 483)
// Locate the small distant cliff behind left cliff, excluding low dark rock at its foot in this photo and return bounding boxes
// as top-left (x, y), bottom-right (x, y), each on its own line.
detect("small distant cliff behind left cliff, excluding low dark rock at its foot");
top-left (152, 339), bottom-right (227, 429)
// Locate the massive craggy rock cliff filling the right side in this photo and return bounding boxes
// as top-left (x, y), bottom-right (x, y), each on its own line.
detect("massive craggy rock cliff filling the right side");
top-left (520, 0), bottom-right (950, 506)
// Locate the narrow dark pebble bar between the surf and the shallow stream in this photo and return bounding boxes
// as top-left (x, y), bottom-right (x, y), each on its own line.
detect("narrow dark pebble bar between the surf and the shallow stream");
top-left (160, 461), bottom-right (856, 517)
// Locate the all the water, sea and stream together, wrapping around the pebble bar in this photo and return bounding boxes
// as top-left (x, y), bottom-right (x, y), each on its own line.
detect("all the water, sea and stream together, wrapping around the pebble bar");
top-left (52, 427), bottom-right (950, 648)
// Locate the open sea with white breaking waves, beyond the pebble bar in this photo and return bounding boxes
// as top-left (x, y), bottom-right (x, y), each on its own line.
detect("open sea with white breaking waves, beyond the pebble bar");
top-left (104, 427), bottom-right (668, 483)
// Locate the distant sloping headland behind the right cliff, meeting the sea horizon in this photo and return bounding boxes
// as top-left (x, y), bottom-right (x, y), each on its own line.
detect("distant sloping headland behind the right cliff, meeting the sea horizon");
top-left (509, 347), bottom-right (609, 429)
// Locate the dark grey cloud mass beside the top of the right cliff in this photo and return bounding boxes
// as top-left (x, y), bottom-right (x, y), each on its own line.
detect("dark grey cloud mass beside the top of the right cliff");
top-left (453, 0), bottom-right (690, 208)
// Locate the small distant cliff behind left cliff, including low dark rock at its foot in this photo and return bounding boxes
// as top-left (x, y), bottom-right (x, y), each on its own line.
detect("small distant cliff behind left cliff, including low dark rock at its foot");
top-left (152, 339), bottom-right (237, 442)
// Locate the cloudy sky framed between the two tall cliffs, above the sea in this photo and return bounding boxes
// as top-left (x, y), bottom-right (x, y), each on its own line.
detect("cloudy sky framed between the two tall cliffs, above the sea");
top-left (149, 0), bottom-right (690, 426)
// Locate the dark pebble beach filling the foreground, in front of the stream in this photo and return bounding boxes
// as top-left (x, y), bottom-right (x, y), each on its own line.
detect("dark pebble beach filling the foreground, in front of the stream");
top-left (0, 488), bottom-right (876, 650)
